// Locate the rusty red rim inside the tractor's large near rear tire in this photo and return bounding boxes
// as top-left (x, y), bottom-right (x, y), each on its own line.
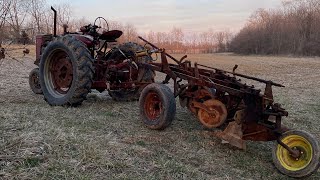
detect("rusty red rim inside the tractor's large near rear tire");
top-left (44, 50), bottom-right (73, 98)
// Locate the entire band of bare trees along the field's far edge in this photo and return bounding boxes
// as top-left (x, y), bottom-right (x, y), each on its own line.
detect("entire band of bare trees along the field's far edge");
top-left (0, 0), bottom-right (320, 55)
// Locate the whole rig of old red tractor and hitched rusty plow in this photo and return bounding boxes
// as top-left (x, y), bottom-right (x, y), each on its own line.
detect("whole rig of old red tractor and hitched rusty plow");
top-left (23, 8), bottom-right (320, 177)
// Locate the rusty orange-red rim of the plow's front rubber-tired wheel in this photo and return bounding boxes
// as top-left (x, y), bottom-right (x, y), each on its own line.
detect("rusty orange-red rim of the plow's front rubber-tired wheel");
top-left (144, 92), bottom-right (163, 121)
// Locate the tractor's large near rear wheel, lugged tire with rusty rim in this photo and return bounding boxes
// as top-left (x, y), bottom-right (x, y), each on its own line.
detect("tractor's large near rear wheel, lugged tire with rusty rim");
top-left (40, 35), bottom-right (94, 106)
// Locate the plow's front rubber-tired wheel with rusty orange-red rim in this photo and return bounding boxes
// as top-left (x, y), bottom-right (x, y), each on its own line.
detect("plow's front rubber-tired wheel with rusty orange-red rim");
top-left (139, 83), bottom-right (176, 130)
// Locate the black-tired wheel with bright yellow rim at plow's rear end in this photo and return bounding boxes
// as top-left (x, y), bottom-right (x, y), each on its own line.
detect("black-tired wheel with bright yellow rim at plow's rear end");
top-left (272, 130), bottom-right (320, 178)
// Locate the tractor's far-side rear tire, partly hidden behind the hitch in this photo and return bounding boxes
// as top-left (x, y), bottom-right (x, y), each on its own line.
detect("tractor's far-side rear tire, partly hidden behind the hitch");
top-left (108, 42), bottom-right (155, 101)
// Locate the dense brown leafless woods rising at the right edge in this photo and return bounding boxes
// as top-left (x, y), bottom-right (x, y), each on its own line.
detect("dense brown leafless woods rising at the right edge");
top-left (231, 0), bottom-right (320, 56)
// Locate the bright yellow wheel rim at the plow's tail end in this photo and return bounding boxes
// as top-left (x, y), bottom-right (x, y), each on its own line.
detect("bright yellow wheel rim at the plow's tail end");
top-left (277, 135), bottom-right (313, 171)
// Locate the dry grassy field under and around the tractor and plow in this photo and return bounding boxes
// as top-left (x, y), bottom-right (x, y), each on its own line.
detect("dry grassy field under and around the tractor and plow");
top-left (0, 46), bottom-right (320, 180)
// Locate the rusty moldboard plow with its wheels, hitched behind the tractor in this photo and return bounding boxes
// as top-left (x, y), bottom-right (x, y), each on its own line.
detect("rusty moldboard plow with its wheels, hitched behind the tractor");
top-left (138, 37), bottom-right (320, 177)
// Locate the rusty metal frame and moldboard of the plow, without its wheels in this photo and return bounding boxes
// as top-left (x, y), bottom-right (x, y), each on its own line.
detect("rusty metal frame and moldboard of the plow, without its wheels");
top-left (139, 37), bottom-right (292, 148)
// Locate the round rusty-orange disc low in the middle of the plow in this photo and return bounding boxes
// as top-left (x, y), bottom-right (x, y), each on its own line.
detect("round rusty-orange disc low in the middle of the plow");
top-left (198, 99), bottom-right (228, 128)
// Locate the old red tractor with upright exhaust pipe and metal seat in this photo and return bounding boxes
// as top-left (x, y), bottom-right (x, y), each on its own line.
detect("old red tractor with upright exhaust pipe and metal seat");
top-left (29, 8), bottom-right (155, 106)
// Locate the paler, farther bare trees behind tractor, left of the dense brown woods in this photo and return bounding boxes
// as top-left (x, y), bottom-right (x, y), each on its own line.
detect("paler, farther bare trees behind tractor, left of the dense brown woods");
top-left (0, 0), bottom-right (232, 53)
